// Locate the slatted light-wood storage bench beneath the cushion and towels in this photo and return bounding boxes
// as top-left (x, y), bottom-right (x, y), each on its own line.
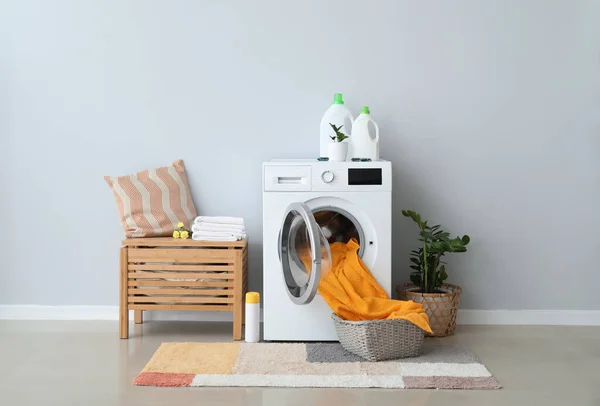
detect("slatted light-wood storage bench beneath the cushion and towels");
top-left (119, 237), bottom-right (248, 340)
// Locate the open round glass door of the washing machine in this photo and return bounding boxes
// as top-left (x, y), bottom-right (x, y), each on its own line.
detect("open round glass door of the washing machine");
top-left (279, 203), bottom-right (331, 305)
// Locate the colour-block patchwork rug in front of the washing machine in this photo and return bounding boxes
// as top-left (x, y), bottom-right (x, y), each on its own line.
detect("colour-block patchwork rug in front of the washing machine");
top-left (133, 341), bottom-right (500, 389)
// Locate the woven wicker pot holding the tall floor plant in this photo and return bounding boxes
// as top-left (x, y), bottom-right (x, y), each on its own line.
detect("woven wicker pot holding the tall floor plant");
top-left (396, 283), bottom-right (462, 337)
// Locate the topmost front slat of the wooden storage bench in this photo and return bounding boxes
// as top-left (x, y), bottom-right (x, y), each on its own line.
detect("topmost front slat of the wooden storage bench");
top-left (128, 248), bottom-right (236, 264)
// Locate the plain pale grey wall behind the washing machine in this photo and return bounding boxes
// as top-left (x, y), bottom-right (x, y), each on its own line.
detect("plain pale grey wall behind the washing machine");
top-left (0, 0), bottom-right (600, 309)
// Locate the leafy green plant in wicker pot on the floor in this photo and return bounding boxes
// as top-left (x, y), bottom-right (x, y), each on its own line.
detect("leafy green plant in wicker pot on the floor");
top-left (396, 210), bottom-right (471, 337)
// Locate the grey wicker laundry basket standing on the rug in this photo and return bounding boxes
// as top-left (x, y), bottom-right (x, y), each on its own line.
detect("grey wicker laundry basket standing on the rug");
top-left (331, 314), bottom-right (425, 361)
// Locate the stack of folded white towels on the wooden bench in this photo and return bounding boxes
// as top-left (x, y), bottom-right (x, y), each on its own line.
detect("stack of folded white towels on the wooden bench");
top-left (192, 216), bottom-right (246, 241)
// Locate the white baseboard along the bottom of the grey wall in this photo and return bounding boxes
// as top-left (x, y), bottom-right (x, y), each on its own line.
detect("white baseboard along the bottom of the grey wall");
top-left (0, 305), bottom-right (600, 326)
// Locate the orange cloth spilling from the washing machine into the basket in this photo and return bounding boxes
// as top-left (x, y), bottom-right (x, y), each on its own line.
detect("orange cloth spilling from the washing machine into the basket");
top-left (318, 238), bottom-right (432, 333)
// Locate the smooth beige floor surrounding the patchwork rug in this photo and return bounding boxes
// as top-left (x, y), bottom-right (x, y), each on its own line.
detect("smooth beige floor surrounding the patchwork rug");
top-left (0, 321), bottom-right (600, 406)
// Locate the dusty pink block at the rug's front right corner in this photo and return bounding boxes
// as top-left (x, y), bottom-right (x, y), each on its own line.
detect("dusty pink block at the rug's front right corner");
top-left (402, 376), bottom-right (501, 389)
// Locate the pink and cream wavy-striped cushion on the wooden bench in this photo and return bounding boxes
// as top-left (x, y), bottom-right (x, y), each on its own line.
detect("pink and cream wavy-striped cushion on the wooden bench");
top-left (104, 160), bottom-right (196, 238)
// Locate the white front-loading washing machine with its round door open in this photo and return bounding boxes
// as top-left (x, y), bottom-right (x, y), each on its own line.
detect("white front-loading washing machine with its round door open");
top-left (263, 159), bottom-right (392, 341)
